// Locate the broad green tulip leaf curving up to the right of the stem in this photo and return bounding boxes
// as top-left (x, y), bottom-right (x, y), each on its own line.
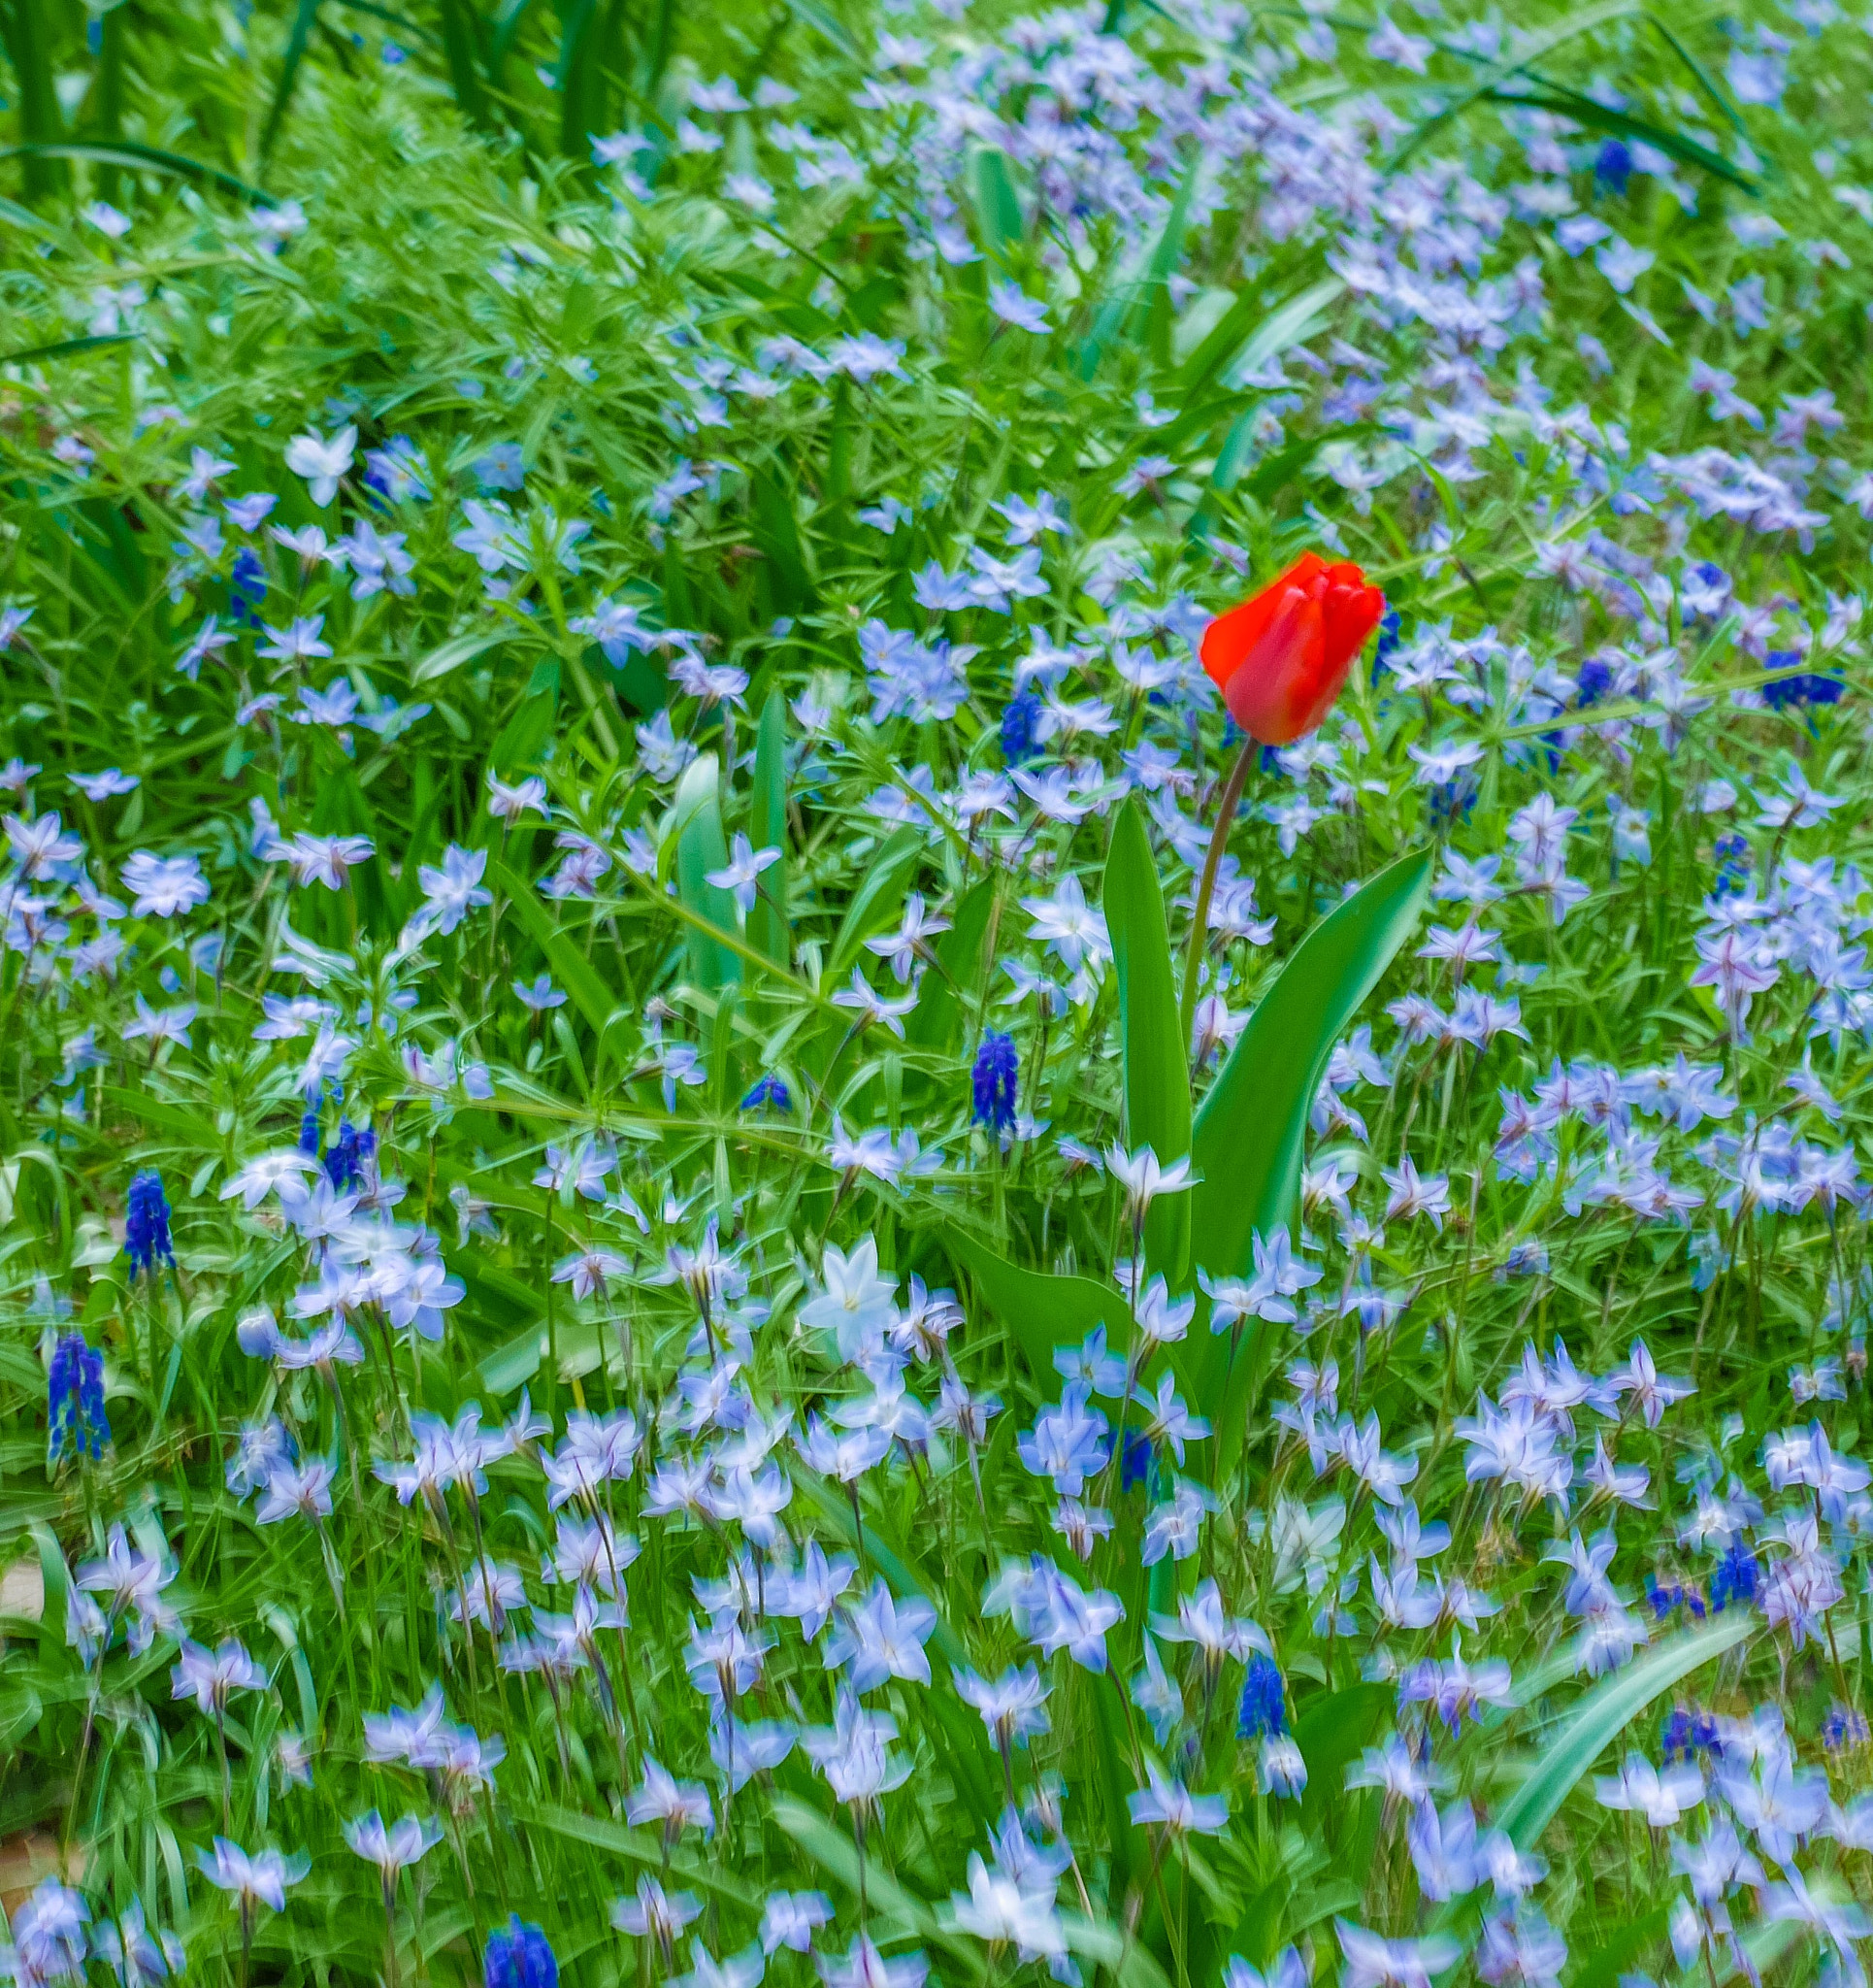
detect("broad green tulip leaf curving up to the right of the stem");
top-left (1185, 848), bottom-right (1431, 1472)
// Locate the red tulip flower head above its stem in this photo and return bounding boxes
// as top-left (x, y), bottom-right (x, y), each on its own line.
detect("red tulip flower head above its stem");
top-left (1203, 552), bottom-right (1386, 746)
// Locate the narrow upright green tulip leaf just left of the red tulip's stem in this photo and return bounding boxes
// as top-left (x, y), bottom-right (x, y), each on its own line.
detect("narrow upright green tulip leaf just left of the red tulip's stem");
top-left (1103, 795), bottom-right (1191, 1288)
